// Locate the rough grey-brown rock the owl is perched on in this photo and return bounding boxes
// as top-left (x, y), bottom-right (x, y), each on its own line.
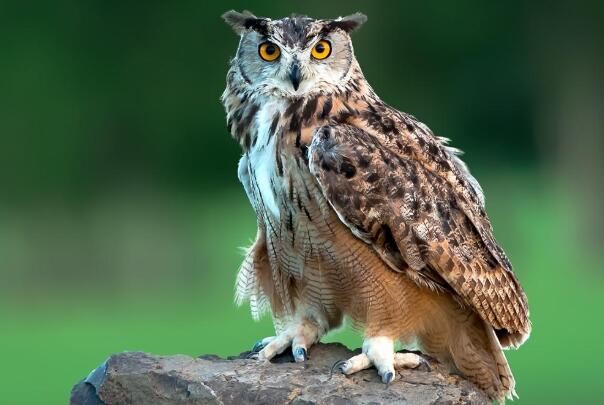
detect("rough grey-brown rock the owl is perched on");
top-left (70, 343), bottom-right (490, 405)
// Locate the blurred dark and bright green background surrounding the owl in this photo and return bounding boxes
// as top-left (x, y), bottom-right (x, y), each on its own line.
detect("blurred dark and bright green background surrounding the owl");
top-left (0, 0), bottom-right (604, 404)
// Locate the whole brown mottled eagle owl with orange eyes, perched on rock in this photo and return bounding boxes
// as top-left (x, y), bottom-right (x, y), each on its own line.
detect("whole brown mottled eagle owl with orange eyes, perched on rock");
top-left (222, 11), bottom-right (531, 400)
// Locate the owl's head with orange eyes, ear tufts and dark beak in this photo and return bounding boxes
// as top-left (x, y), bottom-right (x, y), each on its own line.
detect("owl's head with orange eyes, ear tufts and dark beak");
top-left (222, 11), bottom-right (367, 97)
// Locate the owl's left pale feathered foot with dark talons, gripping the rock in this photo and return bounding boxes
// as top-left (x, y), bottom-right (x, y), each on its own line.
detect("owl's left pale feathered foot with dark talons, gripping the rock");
top-left (248, 320), bottom-right (320, 362)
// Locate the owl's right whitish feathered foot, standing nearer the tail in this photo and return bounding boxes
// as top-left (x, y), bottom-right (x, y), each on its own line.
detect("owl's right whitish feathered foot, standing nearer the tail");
top-left (331, 337), bottom-right (425, 384)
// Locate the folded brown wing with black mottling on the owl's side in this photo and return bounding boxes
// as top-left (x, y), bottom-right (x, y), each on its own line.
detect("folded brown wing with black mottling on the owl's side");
top-left (309, 125), bottom-right (530, 342)
